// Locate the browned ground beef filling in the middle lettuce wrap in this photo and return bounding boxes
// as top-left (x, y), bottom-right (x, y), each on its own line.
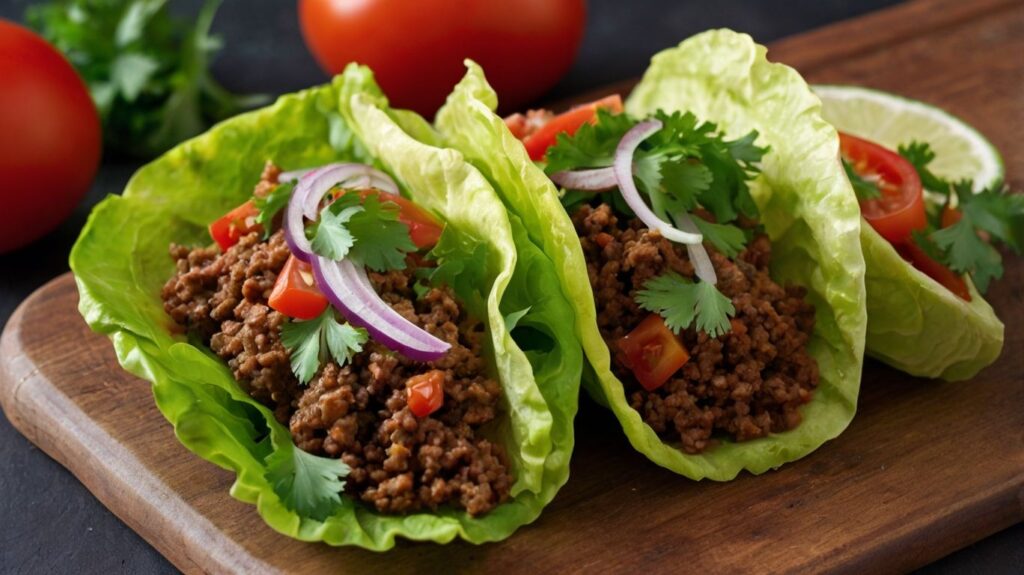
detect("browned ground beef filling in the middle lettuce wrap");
top-left (572, 204), bottom-right (818, 453)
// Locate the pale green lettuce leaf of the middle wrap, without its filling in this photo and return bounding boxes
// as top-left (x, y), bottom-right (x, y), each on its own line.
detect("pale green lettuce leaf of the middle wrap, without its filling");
top-left (436, 30), bottom-right (867, 481)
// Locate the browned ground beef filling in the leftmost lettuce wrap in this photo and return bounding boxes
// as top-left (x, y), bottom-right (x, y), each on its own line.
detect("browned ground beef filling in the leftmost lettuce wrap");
top-left (162, 163), bottom-right (512, 516)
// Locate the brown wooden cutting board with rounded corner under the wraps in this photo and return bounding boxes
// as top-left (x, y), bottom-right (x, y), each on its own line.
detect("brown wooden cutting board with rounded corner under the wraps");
top-left (0, 0), bottom-right (1024, 573)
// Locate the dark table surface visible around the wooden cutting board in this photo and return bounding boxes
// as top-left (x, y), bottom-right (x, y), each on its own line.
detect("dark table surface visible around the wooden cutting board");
top-left (0, 0), bottom-right (1024, 574)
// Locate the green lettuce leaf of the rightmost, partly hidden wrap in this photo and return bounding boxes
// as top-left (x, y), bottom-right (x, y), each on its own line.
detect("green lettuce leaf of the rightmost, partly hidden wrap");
top-left (861, 223), bottom-right (1004, 382)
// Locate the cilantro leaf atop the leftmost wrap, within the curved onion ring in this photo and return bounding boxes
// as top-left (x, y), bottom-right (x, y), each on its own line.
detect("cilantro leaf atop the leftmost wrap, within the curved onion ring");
top-left (310, 193), bottom-right (417, 271)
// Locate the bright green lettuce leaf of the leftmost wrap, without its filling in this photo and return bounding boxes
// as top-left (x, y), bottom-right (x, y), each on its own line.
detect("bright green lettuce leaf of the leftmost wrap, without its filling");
top-left (70, 67), bottom-right (583, 550)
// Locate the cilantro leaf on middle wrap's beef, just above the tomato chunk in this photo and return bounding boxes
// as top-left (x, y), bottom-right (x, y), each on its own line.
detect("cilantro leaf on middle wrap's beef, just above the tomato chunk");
top-left (636, 271), bottom-right (736, 338)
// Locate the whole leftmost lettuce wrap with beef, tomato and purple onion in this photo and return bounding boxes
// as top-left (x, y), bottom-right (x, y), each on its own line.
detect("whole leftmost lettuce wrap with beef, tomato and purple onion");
top-left (71, 67), bottom-right (583, 549)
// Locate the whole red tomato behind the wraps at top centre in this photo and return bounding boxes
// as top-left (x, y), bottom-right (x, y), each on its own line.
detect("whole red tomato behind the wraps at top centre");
top-left (299, 0), bottom-right (587, 117)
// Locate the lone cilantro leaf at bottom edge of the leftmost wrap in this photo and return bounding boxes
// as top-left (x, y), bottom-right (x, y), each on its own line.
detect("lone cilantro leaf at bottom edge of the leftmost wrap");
top-left (265, 445), bottom-right (351, 521)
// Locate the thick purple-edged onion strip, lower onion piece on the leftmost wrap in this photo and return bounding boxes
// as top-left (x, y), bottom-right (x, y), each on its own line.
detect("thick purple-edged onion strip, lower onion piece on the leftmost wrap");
top-left (312, 256), bottom-right (452, 361)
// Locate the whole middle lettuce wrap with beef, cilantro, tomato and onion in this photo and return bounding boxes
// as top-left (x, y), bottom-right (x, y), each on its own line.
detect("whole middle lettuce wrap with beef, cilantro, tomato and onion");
top-left (436, 31), bottom-right (866, 480)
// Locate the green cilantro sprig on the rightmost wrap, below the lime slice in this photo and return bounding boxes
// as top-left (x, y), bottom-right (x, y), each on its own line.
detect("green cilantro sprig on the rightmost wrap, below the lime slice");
top-left (898, 141), bottom-right (1024, 294)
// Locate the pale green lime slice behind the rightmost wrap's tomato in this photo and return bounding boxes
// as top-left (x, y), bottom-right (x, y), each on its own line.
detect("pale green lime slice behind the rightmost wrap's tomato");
top-left (813, 86), bottom-right (1002, 191)
